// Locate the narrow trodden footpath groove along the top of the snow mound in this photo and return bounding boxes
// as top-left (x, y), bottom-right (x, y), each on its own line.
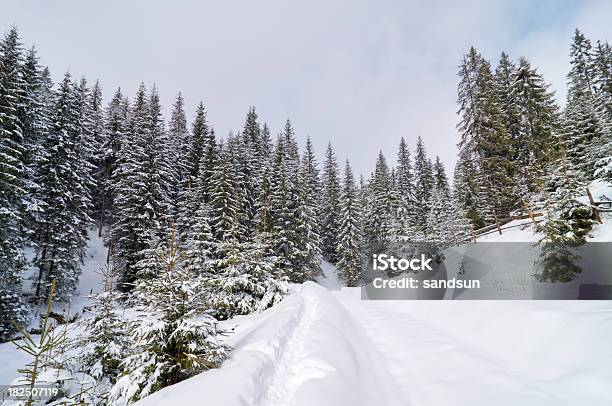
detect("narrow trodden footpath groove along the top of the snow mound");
top-left (259, 295), bottom-right (319, 406)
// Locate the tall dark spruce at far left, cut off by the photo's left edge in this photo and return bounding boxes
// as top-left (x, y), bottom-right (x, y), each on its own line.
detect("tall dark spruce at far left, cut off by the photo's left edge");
top-left (0, 27), bottom-right (26, 341)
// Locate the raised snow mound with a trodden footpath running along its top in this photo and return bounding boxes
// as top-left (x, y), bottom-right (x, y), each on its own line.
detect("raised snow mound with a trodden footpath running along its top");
top-left (138, 282), bottom-right (406, 406)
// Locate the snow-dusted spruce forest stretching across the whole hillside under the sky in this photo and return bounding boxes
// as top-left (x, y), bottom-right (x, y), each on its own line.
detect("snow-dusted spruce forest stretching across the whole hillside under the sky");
top-left (0, 28), bottom-right (612, 399)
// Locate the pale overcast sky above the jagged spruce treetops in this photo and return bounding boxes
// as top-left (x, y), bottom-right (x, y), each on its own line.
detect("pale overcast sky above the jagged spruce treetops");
top-left (0, 0), bottom-right (612, 175)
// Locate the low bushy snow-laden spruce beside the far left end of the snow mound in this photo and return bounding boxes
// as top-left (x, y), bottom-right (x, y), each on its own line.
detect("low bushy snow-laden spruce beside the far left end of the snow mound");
top-left (209, 238), bottom-right (287, 319)
